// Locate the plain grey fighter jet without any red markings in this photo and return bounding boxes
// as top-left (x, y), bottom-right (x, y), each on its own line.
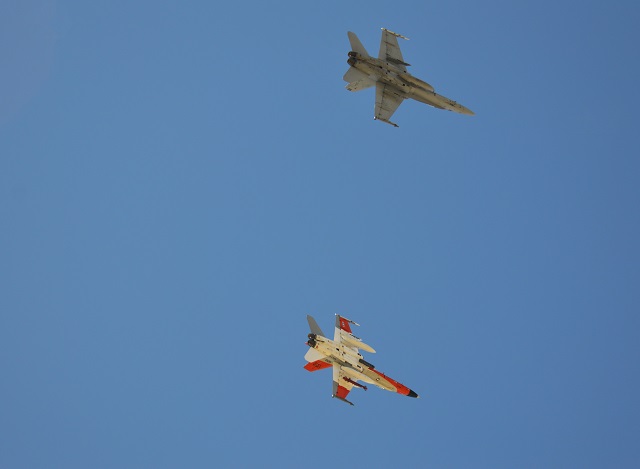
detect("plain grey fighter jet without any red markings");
top-left (342, 28), bottom-right (474, 127)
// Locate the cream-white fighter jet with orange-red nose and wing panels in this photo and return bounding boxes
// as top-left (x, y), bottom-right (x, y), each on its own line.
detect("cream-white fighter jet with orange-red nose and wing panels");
top-left (304, 315), bottom-right (418, 405)
